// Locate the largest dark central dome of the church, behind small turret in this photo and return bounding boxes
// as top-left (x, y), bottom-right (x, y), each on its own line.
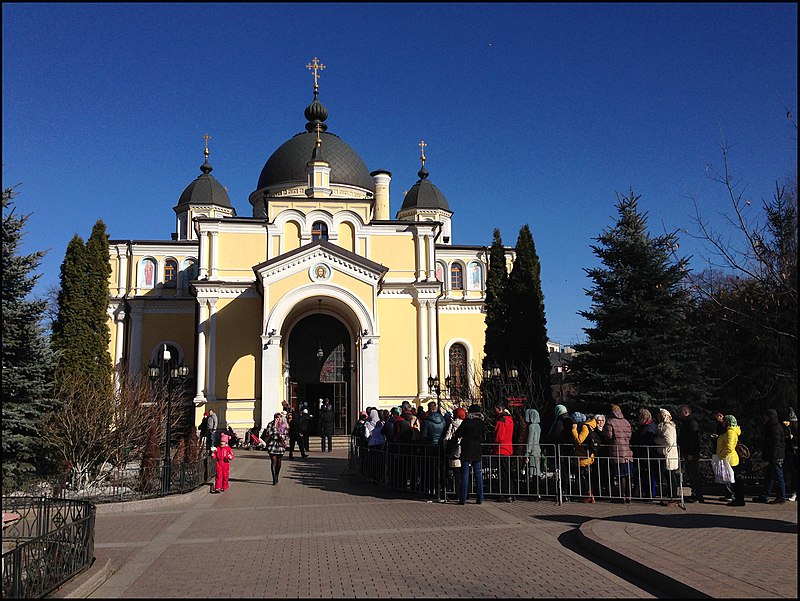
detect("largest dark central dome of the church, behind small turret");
top-left (256, 131), bottom-right (375, 192)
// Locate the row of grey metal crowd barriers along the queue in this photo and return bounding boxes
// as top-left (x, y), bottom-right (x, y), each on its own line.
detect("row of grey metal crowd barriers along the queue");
top-left (348, 437), bottom-right (684, 507)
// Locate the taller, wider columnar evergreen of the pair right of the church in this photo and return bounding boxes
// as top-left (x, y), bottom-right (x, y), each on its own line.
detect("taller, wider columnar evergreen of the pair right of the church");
top-left (504, 224), bottom-right (551, 407)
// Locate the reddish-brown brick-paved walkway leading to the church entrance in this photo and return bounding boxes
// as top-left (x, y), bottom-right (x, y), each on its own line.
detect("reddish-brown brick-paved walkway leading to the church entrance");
top-left (52, 450), bottom-right (797, 598)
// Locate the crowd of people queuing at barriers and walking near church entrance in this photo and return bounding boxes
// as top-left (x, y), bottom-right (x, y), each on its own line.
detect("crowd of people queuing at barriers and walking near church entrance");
top-left (200, 399), bottom-right (798, 507)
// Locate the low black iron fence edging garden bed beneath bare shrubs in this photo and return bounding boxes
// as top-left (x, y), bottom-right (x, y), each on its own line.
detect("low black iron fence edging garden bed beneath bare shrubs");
top-left (3, 457), bottom-right (216, 503)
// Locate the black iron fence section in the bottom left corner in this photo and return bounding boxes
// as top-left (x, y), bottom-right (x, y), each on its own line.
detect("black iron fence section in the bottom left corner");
top-left (2, 497), bottom-right (95, 599)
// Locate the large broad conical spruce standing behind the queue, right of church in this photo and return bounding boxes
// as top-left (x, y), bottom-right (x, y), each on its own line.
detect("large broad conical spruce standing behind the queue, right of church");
top-left (569, 191), bottom-right (704, 413)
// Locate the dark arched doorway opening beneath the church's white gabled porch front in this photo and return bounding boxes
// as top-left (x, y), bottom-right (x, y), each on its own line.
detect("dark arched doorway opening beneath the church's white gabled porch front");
top-left (287, 313), bottom-right (353, 434)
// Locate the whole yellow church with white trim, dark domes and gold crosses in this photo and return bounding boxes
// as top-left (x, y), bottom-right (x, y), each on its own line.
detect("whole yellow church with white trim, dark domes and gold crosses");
top-left (109, 59), bottom-right (513, 433)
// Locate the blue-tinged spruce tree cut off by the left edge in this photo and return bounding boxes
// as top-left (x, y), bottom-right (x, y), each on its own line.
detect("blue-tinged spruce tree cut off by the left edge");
top-left (2, 188), bottom-right (53, 488)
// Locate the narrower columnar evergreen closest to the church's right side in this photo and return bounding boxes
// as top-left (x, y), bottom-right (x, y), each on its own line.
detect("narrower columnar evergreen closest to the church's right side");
top-left (483, 229), bottom-right (508, 372)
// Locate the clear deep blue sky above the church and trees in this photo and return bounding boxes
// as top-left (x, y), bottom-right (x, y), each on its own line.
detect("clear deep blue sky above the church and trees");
top-left (2, 3), bottom-right (797, 344)
